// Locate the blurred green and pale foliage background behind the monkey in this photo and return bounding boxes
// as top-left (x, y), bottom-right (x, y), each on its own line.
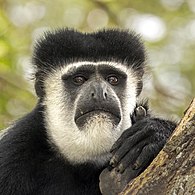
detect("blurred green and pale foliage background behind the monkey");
top-left (0, 0), bottom-right (195, 129)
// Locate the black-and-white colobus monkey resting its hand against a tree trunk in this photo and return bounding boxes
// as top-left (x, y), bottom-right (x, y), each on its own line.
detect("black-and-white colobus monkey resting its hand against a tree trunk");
top-left (0, 29), bottom-right (175, 195)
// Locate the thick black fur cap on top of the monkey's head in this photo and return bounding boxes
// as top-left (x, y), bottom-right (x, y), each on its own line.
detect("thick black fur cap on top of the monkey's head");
top-left (33, 29), bottom-right (145, 74)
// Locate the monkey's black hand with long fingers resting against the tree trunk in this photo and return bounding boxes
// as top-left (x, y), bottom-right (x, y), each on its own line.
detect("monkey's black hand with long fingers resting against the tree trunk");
top-left (110, 117), bottom-right (176, 174)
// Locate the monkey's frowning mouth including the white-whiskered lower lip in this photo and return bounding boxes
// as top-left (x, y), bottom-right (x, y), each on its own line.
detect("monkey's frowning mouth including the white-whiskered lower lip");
top-left (75, 109), bottom-right (121, 127)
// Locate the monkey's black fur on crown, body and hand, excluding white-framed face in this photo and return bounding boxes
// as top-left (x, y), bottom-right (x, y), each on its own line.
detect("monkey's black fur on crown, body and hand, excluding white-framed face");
top-left (0, 29), bottom-right (175, 195)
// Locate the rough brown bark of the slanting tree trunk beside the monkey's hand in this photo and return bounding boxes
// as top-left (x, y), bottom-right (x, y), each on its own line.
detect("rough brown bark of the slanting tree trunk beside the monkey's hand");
top-left (120, 98), bottom-right (195, 195)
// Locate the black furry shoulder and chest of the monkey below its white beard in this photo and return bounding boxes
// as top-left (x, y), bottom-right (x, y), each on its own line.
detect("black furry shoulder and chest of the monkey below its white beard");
top-left (0, 106), bottom-right (102, 195)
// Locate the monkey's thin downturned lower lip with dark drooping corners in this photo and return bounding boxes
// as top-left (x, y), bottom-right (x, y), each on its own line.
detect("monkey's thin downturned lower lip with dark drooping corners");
top-left (75, 109), bottom-right (121, 126)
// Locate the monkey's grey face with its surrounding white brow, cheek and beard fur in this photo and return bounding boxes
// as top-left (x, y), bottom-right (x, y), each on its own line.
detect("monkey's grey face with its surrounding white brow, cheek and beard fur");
top-left (43, 61), bottom-right (136, 163)
